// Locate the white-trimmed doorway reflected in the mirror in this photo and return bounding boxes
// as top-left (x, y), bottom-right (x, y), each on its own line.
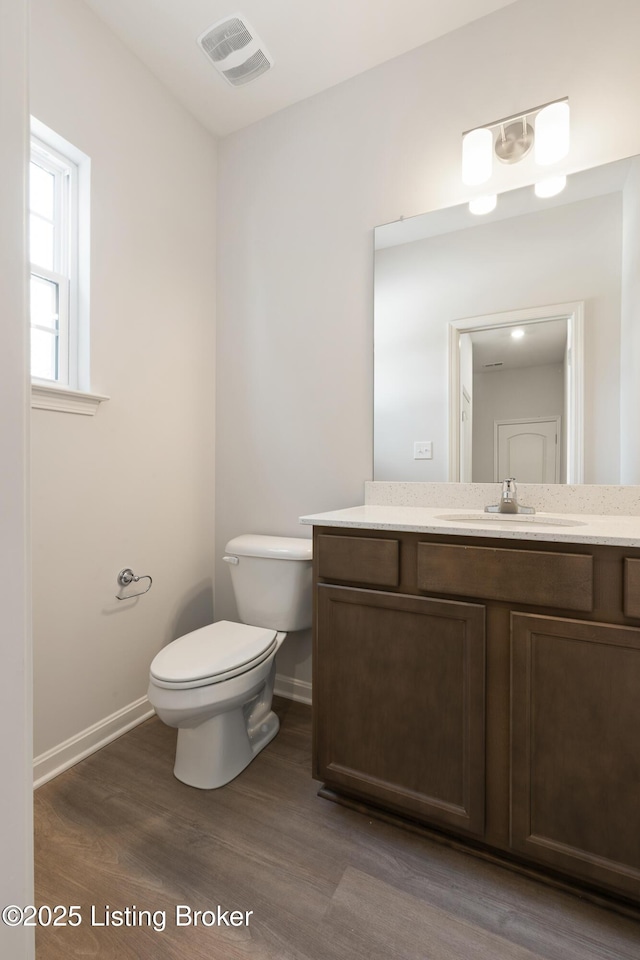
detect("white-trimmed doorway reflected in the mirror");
top-left (448, 303), bottom-right (584, 483)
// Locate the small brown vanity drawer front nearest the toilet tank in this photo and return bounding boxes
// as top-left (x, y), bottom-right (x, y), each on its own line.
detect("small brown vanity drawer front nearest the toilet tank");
top-left (317, 534), bottom-right (400, 587)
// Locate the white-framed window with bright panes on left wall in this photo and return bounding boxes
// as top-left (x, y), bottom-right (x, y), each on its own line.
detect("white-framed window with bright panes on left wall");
top-left (29, 117), bottom-right (105, 412)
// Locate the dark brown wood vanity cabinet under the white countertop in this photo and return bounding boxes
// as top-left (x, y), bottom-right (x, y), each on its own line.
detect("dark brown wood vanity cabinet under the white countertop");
top-left (313, 528), bottom-right (640, 903)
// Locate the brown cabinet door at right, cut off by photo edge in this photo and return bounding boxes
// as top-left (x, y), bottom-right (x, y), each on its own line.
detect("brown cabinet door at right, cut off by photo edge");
top-left (511, 614), bottom-right (640, 898)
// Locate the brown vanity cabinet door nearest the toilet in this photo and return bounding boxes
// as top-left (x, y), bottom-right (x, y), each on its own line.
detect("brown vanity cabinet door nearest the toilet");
top-left (314, 585), bottom-right (485, 835)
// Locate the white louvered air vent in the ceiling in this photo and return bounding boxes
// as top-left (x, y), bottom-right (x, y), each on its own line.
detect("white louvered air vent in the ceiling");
top-left (198, 13), bottom-right (273, 87)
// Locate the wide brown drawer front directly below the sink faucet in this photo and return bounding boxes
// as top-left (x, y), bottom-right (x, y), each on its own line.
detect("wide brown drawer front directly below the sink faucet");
top-left (417, 543), bottom-right (592, 611)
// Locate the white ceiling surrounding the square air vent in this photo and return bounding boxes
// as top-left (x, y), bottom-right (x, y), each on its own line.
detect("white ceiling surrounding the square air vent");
top-left (85, 0), bottom-right (514, 136)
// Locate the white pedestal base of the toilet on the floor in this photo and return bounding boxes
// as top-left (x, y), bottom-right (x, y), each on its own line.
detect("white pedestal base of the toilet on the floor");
top-left (173, 707), bottom-right (280, 790)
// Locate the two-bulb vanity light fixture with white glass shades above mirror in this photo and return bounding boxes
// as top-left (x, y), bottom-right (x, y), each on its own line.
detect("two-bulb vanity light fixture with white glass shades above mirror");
top-left (462, 97), bottom-right (569, 187)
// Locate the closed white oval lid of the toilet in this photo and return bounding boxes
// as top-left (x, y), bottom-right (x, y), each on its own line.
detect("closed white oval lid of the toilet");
top-left (150, 620), bottom-right (277, 686)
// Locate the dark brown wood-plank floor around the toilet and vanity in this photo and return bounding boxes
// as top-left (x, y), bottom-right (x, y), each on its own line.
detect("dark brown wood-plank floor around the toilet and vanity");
top-left (35, 700), bottom-right (640, 960)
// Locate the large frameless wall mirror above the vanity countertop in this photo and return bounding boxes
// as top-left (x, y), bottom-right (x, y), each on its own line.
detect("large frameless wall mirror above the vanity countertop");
top-left (374, 158), bottom-right (640, 484)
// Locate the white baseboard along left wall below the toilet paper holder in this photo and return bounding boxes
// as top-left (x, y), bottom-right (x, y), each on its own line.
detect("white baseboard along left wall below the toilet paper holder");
top-left (33, 697), bottom-right (155, 790)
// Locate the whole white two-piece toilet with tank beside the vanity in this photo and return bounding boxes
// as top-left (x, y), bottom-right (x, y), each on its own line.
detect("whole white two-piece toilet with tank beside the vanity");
top-left (147, 534), bottom-right (312, 790)
